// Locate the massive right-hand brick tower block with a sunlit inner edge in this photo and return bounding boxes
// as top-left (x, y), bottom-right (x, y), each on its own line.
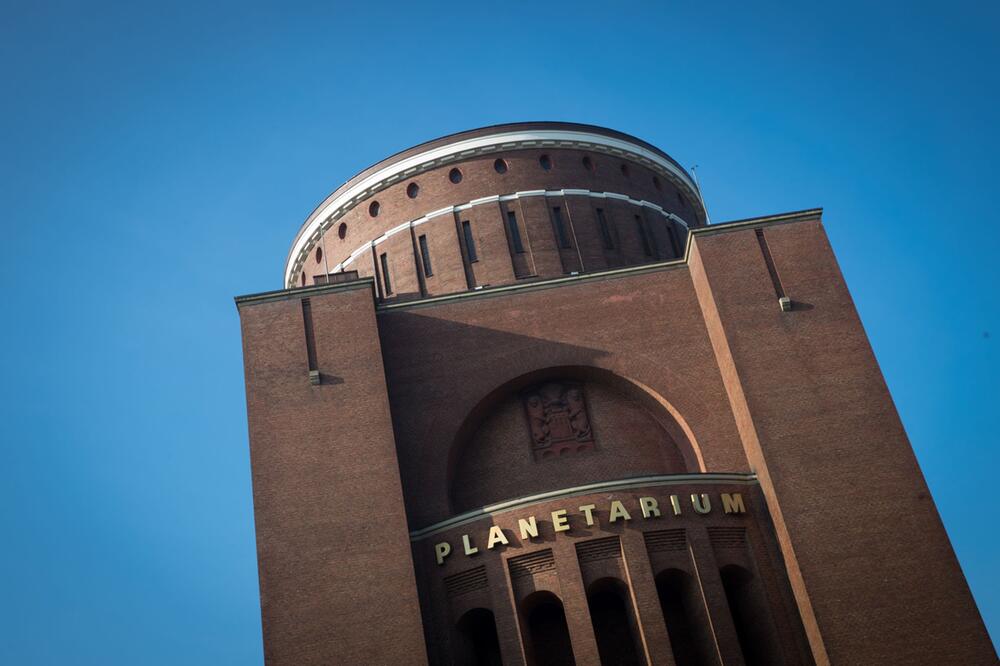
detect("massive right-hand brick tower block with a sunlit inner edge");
top-left (690, 211), bottom-right (995, 665)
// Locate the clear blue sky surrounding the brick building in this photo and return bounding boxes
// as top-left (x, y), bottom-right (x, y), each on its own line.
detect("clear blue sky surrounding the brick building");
top-left (0, 0), bottom-right (1000, 665)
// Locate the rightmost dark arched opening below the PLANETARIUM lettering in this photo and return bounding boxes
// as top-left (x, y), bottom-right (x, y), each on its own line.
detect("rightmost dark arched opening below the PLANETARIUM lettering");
top-left (719, 564), bottom-right (780, 666)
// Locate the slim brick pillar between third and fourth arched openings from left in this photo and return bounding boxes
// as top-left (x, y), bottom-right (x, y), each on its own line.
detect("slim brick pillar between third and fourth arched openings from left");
top-left (621, 530), bottom-right (674, 666)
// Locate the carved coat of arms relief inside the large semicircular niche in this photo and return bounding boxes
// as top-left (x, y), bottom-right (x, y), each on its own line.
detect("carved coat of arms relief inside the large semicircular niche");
top-left (524, 382), bottom-right (594, 460)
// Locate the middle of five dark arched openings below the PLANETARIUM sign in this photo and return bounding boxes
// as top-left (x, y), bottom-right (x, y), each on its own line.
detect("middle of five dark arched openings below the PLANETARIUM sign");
top-left (587, 578), bottom-right (644, 666)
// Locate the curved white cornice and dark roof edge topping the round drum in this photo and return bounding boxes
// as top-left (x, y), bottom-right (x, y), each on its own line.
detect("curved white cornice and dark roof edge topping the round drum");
top-left (283, 121), bottom-right (707, 286)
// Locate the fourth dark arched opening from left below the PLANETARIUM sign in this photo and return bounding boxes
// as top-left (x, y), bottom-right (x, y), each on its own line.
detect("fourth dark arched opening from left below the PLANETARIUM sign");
top-left (656, 569), bottom-right (714, 666)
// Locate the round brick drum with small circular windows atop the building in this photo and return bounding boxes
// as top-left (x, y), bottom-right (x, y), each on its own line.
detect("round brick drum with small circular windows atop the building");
top-left (284, 122), bottom-right (707, 299)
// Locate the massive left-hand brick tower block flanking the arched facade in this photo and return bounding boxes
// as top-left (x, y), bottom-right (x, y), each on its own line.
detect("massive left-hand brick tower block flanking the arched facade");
top-left (237, 278), bottom-right (427, 666)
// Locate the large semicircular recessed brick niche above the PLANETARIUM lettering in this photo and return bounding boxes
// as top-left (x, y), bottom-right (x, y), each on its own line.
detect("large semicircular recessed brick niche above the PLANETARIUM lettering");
top-left (448, 366), bottom-right (702, 513)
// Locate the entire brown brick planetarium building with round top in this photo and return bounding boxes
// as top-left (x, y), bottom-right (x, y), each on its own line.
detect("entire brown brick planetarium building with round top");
top-left (236, 122), bottom-right (995, 666)
